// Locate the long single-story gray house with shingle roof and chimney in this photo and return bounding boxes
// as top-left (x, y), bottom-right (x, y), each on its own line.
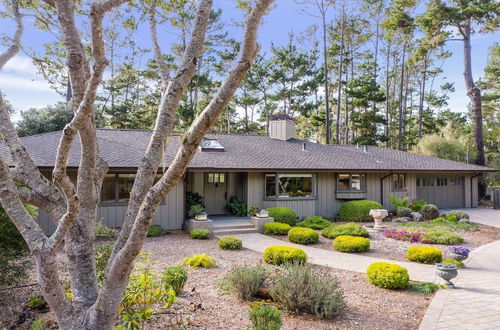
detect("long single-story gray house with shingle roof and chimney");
top-left (0, 115), bottom-right (494, 232)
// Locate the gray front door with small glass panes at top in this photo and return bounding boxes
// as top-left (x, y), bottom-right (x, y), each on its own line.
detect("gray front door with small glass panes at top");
top-left (204, 172), bottom-right (227, 215)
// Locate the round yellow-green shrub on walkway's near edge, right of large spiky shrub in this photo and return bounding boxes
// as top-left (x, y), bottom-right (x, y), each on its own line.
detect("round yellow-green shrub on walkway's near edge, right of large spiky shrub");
top-left (366, 261), bottom-right (410, 289)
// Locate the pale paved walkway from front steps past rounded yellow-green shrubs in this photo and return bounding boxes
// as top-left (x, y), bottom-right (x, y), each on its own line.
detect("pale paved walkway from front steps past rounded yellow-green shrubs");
top-left (220, 234), bottom-right (440, 282)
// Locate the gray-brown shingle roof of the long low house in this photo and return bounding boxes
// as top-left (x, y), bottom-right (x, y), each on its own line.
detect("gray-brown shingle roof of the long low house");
top-left (0, 129), bottom-right (494, 172)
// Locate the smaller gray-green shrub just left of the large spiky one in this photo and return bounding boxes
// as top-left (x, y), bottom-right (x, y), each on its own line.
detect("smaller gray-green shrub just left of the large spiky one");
top-left (219, 265), bottom-right (267, 300)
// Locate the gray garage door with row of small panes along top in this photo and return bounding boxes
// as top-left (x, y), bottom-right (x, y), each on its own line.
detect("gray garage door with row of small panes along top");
top-left (417, 176), bottom-right (465, 208)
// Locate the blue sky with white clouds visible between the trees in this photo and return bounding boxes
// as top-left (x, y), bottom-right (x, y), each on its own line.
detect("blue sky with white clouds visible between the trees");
top-left (0, 0), bottom-right (500, 119)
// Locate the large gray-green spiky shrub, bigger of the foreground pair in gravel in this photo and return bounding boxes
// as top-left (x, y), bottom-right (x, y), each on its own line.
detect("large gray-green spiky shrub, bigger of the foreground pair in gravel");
top-left (269, 263), bottom-right (346, 319)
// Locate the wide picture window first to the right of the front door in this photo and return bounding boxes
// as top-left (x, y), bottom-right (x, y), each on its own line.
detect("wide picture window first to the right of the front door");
top-left (265, 173), bottom-right (315, 199)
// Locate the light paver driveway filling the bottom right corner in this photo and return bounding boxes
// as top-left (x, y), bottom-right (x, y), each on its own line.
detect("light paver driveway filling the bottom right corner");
top-left (420, 241), bottom-right (500, 330)
